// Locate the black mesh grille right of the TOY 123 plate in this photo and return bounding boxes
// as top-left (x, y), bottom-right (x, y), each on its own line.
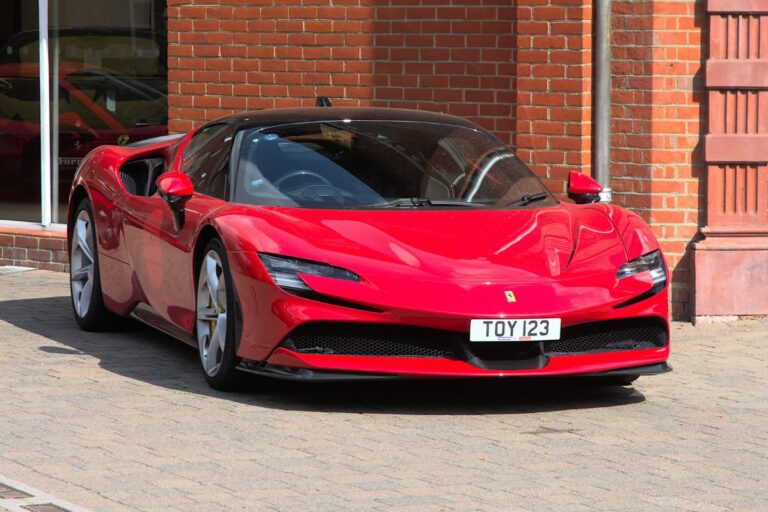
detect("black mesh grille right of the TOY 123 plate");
top-left (544, 318), bottom-right (667, 355)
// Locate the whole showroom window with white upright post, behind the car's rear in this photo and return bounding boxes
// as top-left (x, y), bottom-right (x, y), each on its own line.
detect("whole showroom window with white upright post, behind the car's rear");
top-left (0, 0), bottom-right (168, 224)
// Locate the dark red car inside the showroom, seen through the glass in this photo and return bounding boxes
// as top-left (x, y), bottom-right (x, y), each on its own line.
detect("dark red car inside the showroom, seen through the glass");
top-left (0, 63), bottom-right (168, 203)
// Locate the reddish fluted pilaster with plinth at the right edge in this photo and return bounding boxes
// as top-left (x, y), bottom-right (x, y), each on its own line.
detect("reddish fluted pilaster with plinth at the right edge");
top-left (693, 0), bottom-right (768, 317)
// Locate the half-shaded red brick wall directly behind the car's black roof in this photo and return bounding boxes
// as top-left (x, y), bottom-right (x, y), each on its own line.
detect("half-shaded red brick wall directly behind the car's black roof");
top-left (168, 0), bottom-right (515, 142)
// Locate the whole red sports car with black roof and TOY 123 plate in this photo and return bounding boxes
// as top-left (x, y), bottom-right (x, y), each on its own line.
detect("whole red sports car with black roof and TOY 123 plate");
top-left (68, 107), bottom-right (669, 389)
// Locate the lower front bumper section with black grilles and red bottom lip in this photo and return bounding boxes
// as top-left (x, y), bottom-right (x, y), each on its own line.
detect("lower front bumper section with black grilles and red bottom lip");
top-left (245, 317), bottom-right (669, 377)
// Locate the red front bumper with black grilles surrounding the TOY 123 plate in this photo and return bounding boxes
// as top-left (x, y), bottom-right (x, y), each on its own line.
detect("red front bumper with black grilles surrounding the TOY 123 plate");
top-left (225, 253), bottom-right (670, 380)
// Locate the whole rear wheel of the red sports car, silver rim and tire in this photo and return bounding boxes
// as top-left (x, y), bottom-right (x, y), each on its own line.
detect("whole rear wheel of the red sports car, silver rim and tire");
top-left (69, 199), bottom-right (116, 331)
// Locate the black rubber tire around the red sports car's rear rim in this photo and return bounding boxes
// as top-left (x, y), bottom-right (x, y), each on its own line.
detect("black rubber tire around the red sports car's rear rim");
top-left (69, 199), bottom-right (119, 332)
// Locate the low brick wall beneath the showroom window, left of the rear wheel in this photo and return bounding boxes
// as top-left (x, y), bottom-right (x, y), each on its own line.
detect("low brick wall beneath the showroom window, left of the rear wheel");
top-left (0, 228), bottom-right (69, 272)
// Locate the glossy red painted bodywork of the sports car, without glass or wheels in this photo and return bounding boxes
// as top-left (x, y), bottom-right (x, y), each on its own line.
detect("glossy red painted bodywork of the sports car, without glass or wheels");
top-left (70, 109), bottom-right (669, 376)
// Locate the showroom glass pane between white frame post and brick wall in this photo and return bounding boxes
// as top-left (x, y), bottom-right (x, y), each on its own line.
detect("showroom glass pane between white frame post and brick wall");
top-left (49, 0), bottom-right (168, 222)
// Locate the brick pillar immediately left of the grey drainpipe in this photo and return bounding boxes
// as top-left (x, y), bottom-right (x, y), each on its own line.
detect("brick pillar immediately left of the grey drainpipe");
top-left (513, 0), bottom-right (592, 193)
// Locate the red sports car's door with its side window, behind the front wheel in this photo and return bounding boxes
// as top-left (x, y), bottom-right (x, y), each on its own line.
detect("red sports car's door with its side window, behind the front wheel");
top-left (123, 124), bottom-right (232, 333)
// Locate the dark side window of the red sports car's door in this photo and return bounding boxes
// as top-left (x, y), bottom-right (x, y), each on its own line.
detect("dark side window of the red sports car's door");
top-left (183, 124), bottom-right (232, 199)
